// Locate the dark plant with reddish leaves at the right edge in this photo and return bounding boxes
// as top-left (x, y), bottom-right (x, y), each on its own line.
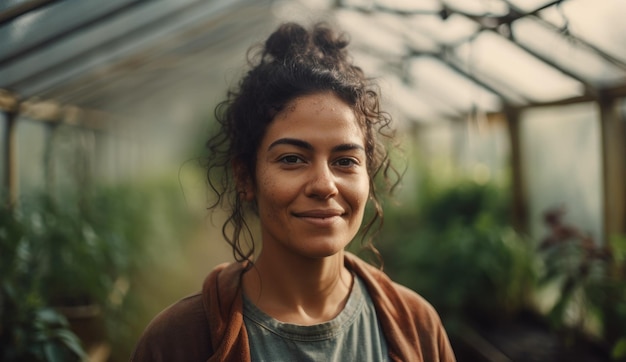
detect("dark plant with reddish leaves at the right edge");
top-left (539, 209), bottom-right (626, 360)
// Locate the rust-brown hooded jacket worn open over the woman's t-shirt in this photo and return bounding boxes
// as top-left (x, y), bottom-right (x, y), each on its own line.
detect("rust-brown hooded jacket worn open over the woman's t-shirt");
top-left (131, 253), bottom-right (455, 362)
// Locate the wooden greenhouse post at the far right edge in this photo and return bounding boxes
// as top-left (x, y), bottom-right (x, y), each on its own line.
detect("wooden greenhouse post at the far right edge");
top-left (598, 97), bottom-right (626, 241)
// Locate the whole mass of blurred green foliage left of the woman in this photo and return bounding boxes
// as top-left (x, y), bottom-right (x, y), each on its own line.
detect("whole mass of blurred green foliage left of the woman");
top-left (0, 180), bottom-right (202, 361)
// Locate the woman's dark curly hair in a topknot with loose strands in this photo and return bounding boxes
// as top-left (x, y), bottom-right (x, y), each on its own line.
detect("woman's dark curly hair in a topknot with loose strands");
top-left (206, 23), bottom-right (400, 261)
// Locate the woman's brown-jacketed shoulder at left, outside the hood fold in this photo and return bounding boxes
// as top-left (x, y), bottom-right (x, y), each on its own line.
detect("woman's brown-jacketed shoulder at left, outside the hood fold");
top-left (132, 293), bottom-right (211, 361)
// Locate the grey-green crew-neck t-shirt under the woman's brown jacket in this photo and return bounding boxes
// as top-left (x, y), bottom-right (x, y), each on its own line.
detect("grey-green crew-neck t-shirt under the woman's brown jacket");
top-left (243, 275), bottom-right (388, 362)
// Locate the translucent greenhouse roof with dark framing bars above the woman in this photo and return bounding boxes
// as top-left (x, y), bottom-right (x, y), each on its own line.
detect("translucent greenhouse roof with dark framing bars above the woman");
top-left (0, 0), bottom-right (626, 122)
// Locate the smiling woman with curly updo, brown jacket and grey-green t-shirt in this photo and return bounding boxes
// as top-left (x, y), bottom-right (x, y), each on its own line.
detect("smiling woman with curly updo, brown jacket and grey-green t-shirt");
top-left (133, 23), bottom-right (454, 361)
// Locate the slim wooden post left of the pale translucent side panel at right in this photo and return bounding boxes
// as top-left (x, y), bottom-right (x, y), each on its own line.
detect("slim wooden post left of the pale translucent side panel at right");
top-left (504, 107), bottom-right (529, 234)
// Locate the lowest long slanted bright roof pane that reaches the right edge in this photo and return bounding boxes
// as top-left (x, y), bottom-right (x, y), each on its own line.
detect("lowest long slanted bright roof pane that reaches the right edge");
top-left (512, 18), bottom-right (626, 86)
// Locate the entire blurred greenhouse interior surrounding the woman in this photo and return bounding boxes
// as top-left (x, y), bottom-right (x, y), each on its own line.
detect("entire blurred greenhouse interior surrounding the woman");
top-left (0, 0), bottom-right (626, 361)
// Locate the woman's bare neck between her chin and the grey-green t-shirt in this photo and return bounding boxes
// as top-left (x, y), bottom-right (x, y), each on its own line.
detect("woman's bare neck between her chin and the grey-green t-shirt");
top-left (243, 251), bottom-right (352, 325)
